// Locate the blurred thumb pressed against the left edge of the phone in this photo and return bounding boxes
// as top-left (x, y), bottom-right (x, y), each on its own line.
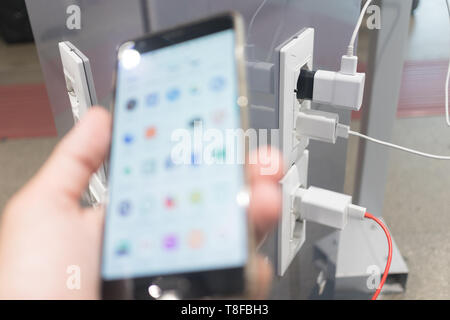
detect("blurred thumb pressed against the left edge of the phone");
top-left (31, 107), bottom-right (111, 202)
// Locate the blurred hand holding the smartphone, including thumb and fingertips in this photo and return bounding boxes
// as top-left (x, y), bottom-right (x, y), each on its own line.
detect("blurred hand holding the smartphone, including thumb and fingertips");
top-left (0, 107), bottom-right (281, 299)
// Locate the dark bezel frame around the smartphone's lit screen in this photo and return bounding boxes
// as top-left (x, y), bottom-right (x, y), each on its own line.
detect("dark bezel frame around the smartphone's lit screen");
top-left (101, 12), bottom-right (253, 299)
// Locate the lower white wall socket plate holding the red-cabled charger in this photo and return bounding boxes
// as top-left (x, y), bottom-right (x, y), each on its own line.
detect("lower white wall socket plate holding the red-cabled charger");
top-left (277, 150), bottom-right (309, 276)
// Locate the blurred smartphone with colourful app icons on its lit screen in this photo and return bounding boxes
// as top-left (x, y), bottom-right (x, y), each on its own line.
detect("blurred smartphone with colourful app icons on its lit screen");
top-left (101, 13), bottom-right (250, 299)
